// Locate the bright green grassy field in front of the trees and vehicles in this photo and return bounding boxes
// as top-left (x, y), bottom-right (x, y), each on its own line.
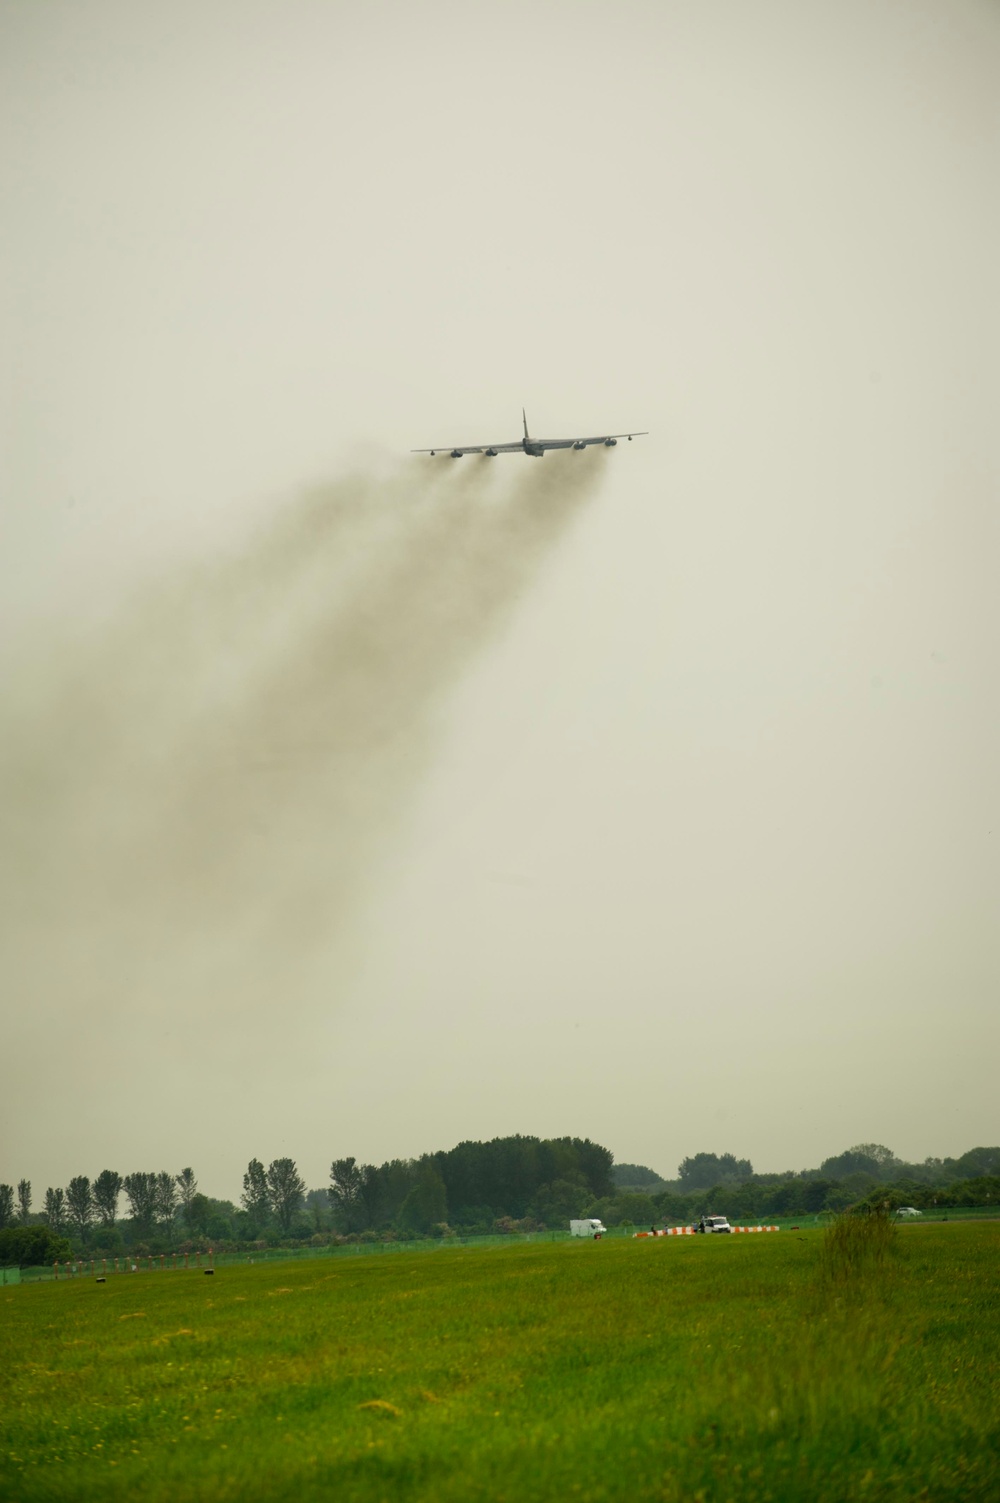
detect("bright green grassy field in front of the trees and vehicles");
top-left (0, 1223), bottom-right (1000, 1503)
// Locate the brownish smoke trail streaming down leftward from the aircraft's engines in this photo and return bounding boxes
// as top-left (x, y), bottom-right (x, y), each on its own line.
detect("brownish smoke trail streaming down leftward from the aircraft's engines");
top-left (0, 451), bottom-right (605, 1058)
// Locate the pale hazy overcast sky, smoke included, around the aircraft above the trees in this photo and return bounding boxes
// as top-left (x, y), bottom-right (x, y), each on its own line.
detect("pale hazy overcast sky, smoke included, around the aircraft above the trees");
top-left (0, 0), bottom-right (1000, 1198)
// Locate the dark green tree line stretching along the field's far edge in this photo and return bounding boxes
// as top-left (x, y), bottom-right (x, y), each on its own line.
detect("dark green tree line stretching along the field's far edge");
top-left (0, 1135), bottom-right (1000, 1266)
